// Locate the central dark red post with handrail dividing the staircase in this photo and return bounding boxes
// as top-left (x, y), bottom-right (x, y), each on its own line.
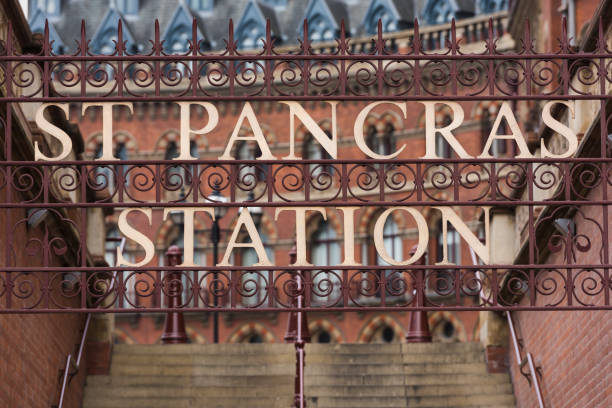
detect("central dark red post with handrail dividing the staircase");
top-left (285, 246), bottom-right (310, 408)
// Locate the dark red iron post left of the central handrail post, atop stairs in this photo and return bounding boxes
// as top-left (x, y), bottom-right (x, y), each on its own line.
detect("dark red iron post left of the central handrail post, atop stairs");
top-left (161, 245), bottom-right (187, 344)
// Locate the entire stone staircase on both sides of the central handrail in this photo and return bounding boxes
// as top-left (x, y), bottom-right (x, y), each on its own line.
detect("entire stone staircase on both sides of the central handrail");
top-left (83, 343), bottom-right (515, 408)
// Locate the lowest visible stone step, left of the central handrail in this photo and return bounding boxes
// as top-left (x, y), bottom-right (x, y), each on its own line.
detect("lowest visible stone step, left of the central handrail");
top-left (83, 396), bottom-right (293, 408)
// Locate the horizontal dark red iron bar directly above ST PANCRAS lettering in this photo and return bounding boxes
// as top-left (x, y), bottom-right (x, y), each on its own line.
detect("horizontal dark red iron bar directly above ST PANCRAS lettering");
top-left (0, 95), bottom-right (612, 103)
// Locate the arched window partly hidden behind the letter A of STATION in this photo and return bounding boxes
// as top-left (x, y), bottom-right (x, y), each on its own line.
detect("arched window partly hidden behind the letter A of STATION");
top-left (240, 234), bottom-right (274, 307)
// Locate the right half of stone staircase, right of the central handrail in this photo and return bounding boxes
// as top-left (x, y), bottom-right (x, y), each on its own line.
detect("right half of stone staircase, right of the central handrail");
top-left (305, 343), bottom-right (515, 408)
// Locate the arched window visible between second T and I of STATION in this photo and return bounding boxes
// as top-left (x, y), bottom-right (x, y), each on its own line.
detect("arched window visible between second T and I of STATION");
top-left (311, 221), bottom-right (341, 302)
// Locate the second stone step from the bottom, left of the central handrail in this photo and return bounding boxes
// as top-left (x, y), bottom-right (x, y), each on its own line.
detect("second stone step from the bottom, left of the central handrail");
top-left (85, 384), bottom-right (293, 400)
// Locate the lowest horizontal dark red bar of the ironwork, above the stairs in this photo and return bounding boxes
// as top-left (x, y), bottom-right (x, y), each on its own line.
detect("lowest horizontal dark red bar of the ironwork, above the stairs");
top-left (0, 305), bottom-right (612, 314)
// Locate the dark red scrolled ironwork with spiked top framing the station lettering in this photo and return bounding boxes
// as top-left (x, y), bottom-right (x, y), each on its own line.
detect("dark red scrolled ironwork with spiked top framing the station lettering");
top-left (0, 17), bottom-right (612, 316)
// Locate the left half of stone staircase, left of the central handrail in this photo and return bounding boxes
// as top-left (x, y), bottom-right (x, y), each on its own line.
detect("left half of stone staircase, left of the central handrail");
top-left (83, 344), bottom-right (295, 408)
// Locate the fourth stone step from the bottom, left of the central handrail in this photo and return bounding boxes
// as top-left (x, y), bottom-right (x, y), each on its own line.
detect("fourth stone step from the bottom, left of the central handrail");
top-left (111, 363), bottom-right (295, 376)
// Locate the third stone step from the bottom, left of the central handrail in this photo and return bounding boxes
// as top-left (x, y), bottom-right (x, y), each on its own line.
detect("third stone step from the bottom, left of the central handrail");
top-left (86, 373), bottom-right (293, 387)
